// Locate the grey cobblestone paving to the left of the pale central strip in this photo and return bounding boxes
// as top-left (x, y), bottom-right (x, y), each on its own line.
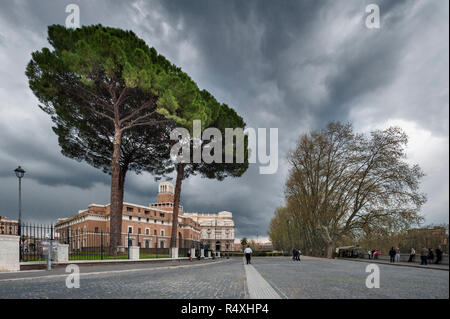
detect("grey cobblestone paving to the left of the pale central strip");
top-left (0, 258), bottom-right (247, 299)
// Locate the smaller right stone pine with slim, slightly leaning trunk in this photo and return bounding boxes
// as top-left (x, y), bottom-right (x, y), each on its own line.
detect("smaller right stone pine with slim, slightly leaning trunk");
top-left (171, 90), bottom-right (248, 254)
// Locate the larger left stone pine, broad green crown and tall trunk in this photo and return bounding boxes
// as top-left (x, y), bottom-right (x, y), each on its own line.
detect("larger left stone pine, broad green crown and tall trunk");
top-left (26, 25), bottom-right (211, 252)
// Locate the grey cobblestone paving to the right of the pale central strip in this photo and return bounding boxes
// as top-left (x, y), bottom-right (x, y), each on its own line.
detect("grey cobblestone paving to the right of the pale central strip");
top-left (252, 257), bottom-right (449, 299)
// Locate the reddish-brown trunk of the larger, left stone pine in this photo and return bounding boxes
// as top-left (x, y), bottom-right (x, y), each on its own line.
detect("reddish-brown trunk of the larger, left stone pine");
top-left (109, 129), bottom-right (125, 256)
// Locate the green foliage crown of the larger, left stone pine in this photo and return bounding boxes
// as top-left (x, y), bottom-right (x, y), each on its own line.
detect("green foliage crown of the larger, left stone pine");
top-left (26, 25), bottom-right (211, 128)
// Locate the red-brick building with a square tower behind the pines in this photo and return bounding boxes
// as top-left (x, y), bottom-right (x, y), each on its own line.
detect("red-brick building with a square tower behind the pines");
top-left (55, 182), bottom-right (200, 249)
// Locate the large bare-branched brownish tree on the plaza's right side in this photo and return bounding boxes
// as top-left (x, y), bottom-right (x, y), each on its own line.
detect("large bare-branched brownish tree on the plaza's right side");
top-left (286, 123), bottom-right (426, 258)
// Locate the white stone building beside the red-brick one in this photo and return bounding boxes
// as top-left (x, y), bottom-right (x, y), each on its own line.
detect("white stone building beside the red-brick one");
top-left (184, 211), bottom-right (235, 251)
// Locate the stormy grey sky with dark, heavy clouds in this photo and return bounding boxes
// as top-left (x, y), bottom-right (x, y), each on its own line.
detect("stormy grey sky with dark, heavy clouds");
top-left (0, 0), bottom-right (449, 237)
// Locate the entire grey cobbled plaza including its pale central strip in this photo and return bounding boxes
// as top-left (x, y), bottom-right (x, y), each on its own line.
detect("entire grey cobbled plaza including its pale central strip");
top-left (0, 257), bottom-right (449, 299)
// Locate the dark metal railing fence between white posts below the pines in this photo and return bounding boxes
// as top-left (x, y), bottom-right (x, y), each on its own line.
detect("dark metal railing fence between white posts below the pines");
top-left (0, 222), bottom-right (203, 261)
